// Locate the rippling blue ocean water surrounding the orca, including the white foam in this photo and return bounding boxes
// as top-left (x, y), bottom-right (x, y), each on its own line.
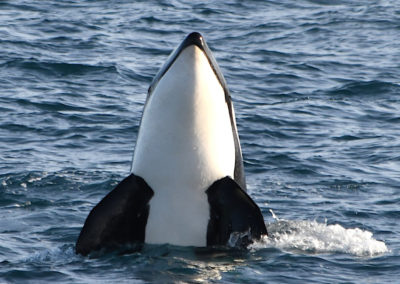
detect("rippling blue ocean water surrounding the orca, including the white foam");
top-left (0, 0), bottom-right (400, 283)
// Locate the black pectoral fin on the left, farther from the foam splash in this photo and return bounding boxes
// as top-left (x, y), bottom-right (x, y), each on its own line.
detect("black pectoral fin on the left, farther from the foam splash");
top-left (75, 174), bottom-right (154, 255)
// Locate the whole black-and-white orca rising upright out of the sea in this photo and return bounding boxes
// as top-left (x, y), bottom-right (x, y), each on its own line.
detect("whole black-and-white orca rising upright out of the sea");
top-left (75, 32), bottom-right (267, 255)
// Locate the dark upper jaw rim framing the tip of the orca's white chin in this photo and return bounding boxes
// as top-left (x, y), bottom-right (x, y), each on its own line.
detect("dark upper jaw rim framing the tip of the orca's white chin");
top-left (148, 32), bottom-right (230, 101)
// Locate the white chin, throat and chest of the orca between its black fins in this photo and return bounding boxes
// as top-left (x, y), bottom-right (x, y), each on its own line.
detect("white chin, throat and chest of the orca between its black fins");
top-left (132, 45), bottom-right (235, 246)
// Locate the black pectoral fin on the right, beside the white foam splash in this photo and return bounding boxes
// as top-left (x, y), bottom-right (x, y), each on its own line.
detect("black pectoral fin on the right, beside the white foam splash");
top-left (206, 177), bottom-right (267, 246)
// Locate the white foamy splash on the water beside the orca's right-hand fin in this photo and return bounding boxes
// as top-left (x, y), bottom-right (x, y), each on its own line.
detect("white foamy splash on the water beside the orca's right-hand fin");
top-left (250, 212), bottom-right (389, 257)
